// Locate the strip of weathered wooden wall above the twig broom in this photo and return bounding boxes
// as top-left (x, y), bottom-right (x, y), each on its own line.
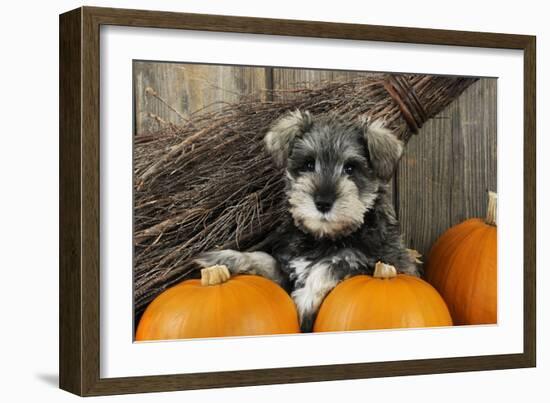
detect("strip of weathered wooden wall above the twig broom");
top-left (133, 61), bottom-right (369, 134)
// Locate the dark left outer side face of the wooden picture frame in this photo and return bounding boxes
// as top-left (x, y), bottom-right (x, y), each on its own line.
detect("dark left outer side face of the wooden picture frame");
top-left (59, 9), bottom-right (84, 394)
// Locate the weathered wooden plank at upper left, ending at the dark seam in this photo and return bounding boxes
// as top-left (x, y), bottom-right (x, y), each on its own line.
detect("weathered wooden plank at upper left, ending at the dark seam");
top-left (134, 61), bottom-right (267, 134)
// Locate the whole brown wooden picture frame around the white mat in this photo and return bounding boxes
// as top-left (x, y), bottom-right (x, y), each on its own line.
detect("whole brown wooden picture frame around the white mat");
top-left (59, 7), bottom-right (536, 396)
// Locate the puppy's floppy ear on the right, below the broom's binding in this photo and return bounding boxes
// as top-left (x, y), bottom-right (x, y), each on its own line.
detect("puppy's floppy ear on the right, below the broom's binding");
top-left (363, 120), bottom-right (403, 180)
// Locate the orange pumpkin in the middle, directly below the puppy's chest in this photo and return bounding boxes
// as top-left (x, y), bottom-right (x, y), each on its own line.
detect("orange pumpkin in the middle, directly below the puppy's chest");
top-left (313, 262), bottom-right (453, 332)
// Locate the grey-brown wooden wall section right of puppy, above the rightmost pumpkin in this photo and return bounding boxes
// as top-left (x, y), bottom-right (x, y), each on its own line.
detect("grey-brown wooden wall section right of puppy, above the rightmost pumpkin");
top-left (396, 78), bottom-right (497, 255)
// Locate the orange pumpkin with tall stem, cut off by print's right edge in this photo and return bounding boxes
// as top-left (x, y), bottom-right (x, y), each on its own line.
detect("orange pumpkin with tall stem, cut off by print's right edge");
top-left (426, 192), bottom-right (497, 325)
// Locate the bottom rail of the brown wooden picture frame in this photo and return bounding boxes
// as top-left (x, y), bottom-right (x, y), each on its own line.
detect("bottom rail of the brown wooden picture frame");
top-left (81, 354), bottom-right (530, 396)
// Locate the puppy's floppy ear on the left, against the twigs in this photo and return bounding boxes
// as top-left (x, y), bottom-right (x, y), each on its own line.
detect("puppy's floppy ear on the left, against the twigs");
top-left (264, 110), bottom-right (312, 167)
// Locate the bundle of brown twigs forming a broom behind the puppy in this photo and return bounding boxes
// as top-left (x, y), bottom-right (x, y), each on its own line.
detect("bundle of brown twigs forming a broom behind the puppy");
top-left (134, 74), bottom-right (475, 316)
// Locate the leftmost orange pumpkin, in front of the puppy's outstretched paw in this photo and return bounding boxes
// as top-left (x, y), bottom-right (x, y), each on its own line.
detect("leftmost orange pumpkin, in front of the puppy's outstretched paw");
top-left (136, 266), bottom-right (300, 341)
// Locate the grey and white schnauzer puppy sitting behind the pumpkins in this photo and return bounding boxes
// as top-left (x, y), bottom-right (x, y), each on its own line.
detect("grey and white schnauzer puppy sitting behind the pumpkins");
top-left (196, 111), bottom-right (419, 332)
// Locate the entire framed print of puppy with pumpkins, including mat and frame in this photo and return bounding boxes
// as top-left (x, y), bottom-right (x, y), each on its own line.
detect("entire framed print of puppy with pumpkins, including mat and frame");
top-left (60, 7), bottom-right (536, 396)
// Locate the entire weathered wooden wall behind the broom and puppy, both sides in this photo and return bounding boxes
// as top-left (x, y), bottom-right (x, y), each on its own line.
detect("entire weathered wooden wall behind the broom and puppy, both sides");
top-left (134, 62), bottom-right (497, 255)
